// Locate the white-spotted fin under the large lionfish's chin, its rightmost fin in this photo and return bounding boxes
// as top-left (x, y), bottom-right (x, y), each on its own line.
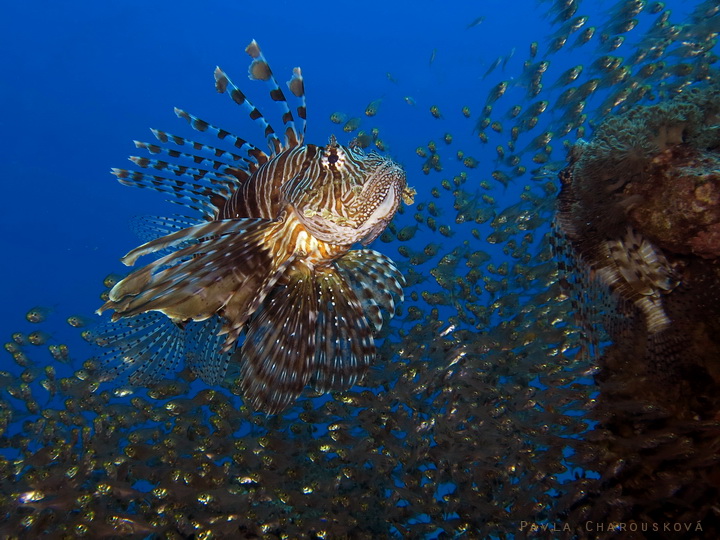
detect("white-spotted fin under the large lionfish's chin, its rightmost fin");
top-left (334, 249), bottom-right (405, 332)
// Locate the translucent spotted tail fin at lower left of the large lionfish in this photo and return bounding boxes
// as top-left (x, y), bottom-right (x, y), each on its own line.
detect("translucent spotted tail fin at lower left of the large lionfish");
top-left (91, 312), bottom-right (185, 385)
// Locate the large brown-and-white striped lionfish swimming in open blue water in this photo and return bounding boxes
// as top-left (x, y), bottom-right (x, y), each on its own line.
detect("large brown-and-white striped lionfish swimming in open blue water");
top-left (96, 40), bottom-right (415, 413)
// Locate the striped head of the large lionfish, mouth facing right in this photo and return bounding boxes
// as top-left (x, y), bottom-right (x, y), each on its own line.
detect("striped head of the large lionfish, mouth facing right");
top-left (285, 137), bottom-right (415, 245)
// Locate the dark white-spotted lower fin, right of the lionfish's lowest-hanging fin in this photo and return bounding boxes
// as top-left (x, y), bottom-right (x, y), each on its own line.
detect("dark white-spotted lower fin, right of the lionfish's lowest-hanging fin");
top-left (311, 267), bottom-right (375, 392)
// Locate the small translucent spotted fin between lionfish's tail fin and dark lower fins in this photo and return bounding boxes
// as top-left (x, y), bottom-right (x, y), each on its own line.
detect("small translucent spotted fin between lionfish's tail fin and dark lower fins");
top-left (185, 315), bottom-right (232, 384)
